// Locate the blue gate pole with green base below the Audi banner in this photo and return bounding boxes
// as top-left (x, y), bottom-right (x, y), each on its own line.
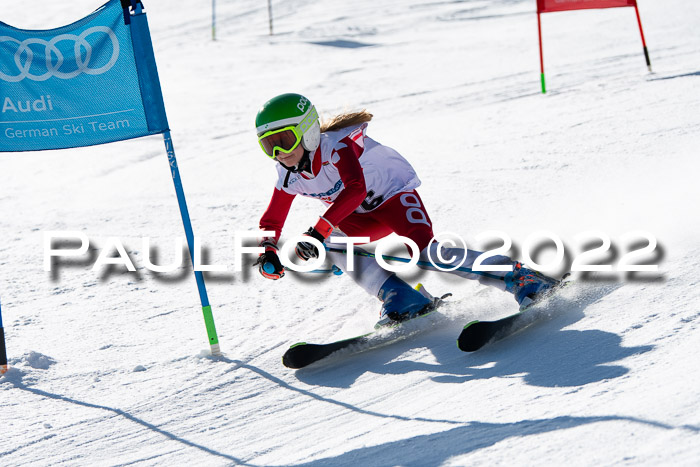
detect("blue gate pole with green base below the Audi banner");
top-left (163, 131), bottom-right (221, 356)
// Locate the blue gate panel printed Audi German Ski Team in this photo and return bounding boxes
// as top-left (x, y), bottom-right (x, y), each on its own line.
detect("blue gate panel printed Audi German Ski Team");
top-left (0, 0), bottom-right (168, 151)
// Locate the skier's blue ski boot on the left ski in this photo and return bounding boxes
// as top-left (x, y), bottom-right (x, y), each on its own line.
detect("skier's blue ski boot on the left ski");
top-left (374, 274), bottom-right (433, 329)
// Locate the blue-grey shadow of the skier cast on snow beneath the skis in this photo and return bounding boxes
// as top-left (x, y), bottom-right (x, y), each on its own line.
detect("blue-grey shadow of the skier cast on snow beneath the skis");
top-left (296, 285), bottom-right (653, 387)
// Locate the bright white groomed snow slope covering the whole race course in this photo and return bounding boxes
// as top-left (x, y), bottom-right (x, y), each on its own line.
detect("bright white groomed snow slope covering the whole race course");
top-left (0, 0), bottom-right (700, 466)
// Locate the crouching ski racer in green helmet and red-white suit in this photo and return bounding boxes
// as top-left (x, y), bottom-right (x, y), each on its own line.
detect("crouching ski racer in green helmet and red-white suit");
top-left (255, 94), bottom-right (558, 326)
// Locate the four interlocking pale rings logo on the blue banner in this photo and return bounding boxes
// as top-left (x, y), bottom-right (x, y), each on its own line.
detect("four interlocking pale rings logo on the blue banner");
top-left (0, 26), bottom-right (119, 83)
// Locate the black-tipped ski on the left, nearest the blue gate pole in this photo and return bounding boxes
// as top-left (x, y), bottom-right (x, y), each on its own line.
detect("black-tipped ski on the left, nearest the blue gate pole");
top-left (282, 284), bottom-right (450, 370)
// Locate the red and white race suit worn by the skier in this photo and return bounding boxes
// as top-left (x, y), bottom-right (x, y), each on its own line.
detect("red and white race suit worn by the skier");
top-left (260, 123), bottom-right (510, 295)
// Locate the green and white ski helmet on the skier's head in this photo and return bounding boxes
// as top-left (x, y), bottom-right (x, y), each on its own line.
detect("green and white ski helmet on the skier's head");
top-left (255, 93), bottom-right (321, 155)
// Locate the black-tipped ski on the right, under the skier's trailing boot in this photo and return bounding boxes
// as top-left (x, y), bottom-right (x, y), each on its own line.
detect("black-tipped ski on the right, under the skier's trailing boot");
top-left (457, 274), bottom-right (573, 352)
